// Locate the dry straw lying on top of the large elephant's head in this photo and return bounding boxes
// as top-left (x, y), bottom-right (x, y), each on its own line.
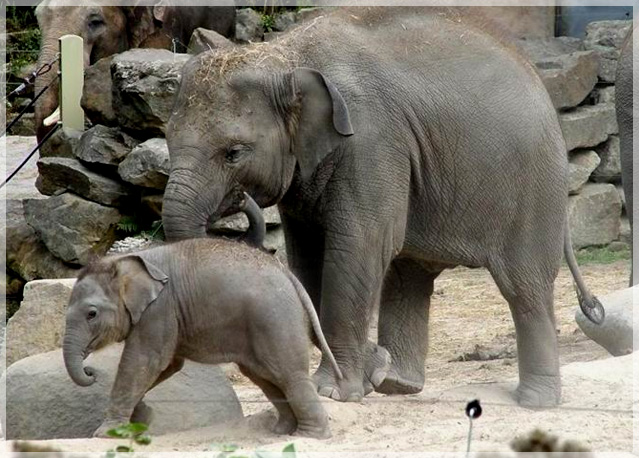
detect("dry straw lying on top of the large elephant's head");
top-left (196, 42), bottom-right (299, 84)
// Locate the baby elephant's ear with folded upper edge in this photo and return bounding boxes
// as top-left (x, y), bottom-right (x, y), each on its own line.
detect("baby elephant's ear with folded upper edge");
top-left (116, 255), bottom-right (169, 325)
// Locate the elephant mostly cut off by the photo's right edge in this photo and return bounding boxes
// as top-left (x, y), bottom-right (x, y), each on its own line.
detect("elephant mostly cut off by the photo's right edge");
top-left (615, 31), bottom-right (639, 286)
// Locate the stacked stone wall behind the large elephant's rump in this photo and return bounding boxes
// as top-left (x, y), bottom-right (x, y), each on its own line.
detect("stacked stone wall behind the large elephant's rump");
top-left (519, 21), bottom-right (632, 249)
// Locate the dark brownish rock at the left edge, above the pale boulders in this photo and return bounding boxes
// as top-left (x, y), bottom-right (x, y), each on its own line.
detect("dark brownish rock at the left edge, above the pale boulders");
top-left (0, 199), bottom-right (76, 281)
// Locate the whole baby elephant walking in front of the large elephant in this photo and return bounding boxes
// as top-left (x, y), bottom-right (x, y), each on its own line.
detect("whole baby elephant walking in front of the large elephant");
top-left (63, 233), bottom-right (339, 438)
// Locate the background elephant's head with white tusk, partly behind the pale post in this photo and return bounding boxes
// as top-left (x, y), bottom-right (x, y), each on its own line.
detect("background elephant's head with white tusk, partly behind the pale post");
top-left (35, 0), bottom-right (165, 140)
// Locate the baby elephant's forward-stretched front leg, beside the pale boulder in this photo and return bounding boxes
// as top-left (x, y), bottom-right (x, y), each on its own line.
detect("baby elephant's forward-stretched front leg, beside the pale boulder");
top-left (93, 341), bottom-right (175, 437)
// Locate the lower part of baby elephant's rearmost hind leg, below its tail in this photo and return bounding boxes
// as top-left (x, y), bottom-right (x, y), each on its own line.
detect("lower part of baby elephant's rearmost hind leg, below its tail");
top-left (282, 374), bottom-right (331, 439)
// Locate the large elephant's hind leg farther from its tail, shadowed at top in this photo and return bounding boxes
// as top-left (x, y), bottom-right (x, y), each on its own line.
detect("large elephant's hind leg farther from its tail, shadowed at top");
top-left (376, 259), bottom-right (439, 394)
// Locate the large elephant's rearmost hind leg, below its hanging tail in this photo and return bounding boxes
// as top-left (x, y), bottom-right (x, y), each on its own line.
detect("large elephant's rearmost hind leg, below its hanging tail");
top-left (492, 266), bottom-right (561, 408)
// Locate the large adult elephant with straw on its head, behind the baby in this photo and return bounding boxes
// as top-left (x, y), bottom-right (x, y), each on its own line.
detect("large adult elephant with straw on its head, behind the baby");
top-left (163, 7), bottom-right (602, 406)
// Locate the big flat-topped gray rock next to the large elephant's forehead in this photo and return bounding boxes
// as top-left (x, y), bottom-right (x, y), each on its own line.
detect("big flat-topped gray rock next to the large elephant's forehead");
top-left (111, 49), bottom-right (191, 138)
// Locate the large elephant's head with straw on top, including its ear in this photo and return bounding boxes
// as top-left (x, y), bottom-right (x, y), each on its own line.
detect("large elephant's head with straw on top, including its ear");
top-left (163, 48), bottom-right (353, 240)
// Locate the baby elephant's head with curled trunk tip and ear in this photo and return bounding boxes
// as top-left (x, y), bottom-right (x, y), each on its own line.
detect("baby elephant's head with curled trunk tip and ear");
top-left (63, 254), bottom-right (168, 386)
